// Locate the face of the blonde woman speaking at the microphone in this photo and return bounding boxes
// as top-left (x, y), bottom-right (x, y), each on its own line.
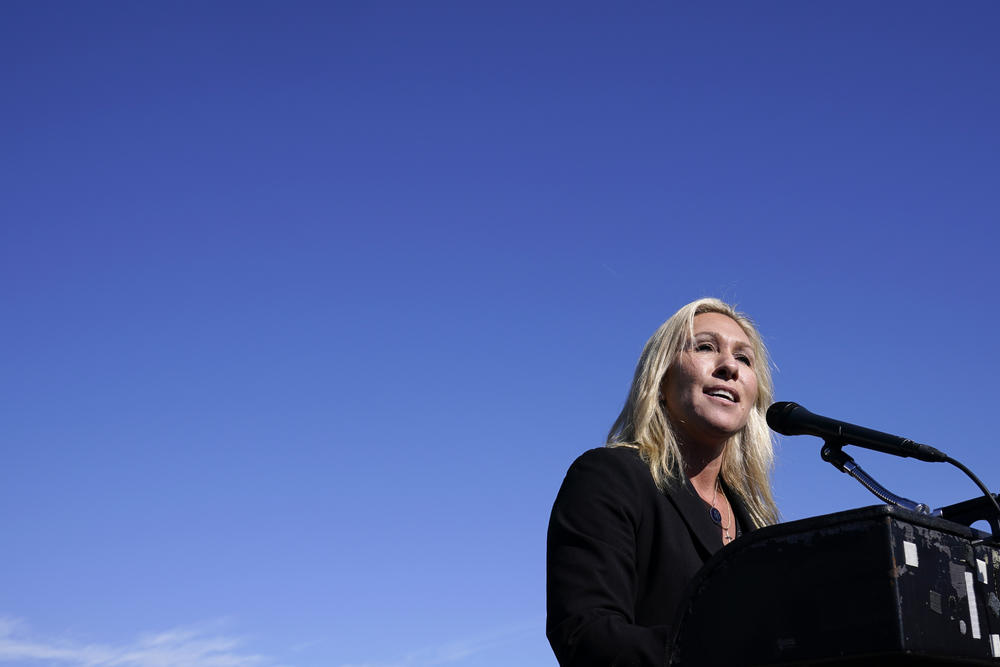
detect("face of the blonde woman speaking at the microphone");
top-left (661, 313), bottom-right (757, 447)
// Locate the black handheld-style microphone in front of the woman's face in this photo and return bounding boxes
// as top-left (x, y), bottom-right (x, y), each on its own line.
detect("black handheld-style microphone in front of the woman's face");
top-left (767, 401), bottom-right (949, 463)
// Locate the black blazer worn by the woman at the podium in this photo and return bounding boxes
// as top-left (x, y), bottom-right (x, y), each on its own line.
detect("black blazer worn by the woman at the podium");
top-left (546, 447), bottom-right (752, 667)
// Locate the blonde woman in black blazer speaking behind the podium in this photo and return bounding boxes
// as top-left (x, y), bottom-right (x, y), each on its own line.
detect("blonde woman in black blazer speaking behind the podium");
top-left (546, 299), bottom-right (778, 667)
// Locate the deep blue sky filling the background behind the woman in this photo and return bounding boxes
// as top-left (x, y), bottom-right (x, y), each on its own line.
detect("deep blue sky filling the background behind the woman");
top-left (0, 0), bottom-right (1000, 667)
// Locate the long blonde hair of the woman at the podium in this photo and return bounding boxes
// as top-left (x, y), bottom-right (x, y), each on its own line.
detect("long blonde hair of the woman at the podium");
top-left (607, 298), bottom-right (778, 526)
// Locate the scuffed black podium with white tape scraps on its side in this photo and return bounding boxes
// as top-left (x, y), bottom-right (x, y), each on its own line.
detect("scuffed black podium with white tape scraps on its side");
top-left (669, 505), bottom-right (1000, 667)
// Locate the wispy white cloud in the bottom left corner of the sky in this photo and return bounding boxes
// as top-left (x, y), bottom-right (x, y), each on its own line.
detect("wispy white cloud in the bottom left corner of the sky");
top-left (0, 617), bottom-right (284, 667)
